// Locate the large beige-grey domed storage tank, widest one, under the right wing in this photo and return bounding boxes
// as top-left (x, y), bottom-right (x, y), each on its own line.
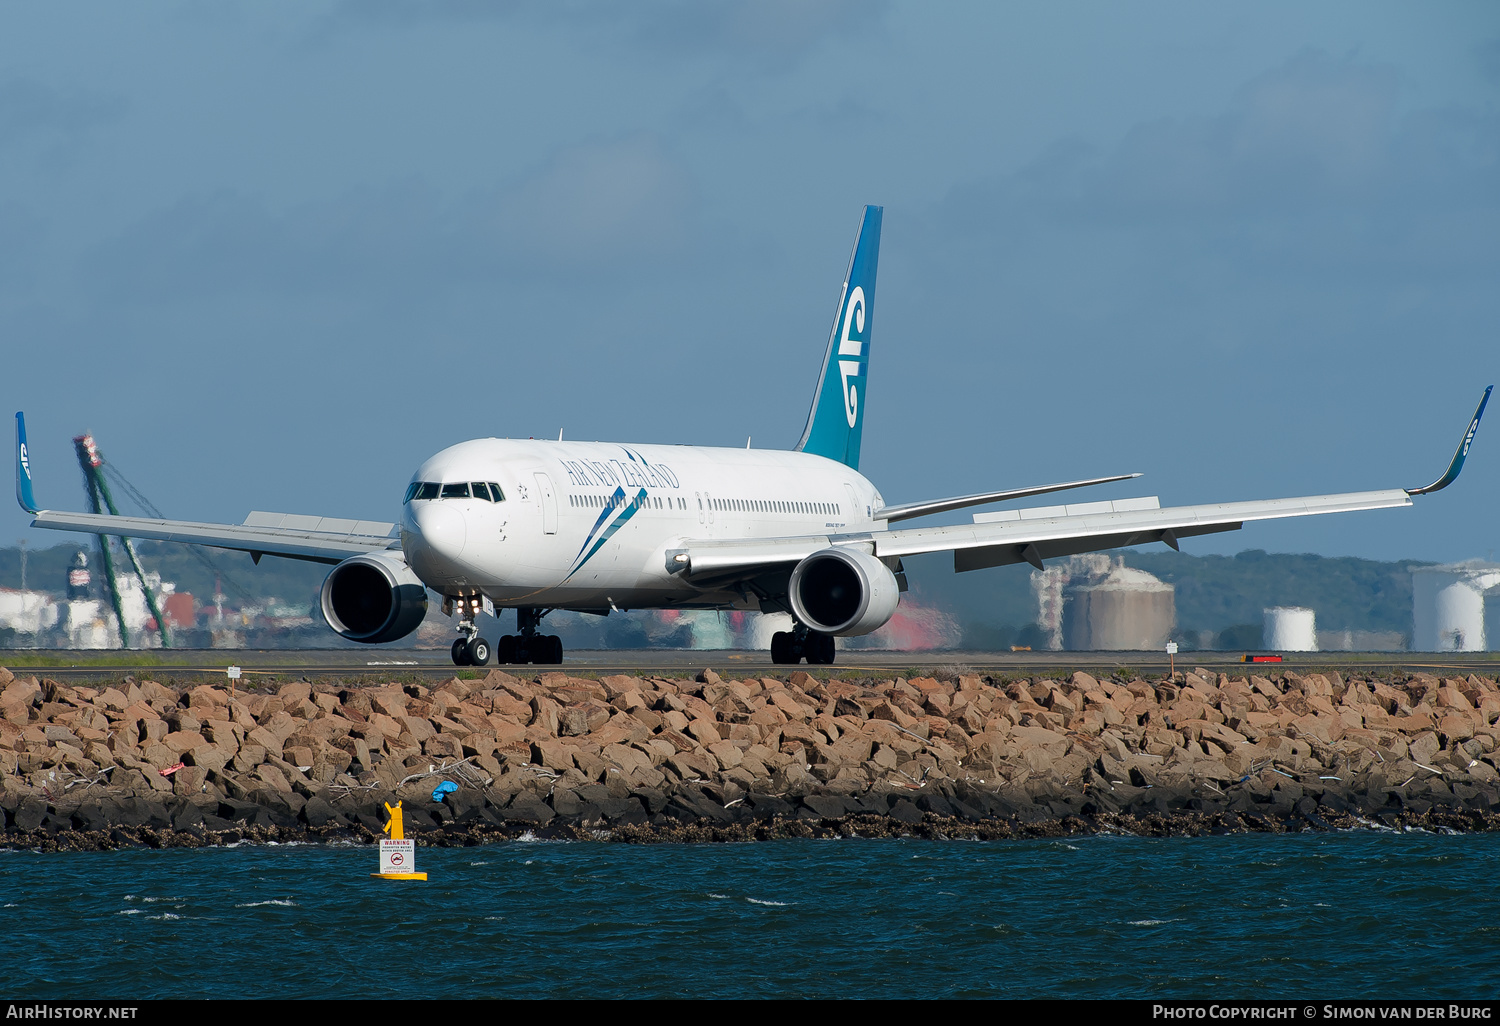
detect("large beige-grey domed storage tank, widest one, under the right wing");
top-left (1062, 563), bottom-right (1178, 653)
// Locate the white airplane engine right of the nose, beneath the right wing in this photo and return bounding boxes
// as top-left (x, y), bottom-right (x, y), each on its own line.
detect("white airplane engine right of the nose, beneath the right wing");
top-left (789, 549), bottom-right (902, 638)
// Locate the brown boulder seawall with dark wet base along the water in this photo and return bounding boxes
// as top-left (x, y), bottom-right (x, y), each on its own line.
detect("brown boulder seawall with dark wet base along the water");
top-left (0, 669), bottom-right (1500, 849)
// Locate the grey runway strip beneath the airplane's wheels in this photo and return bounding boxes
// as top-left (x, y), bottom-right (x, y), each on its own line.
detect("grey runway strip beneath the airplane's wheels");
top-left (0, 648), bottom-right (1500, 684)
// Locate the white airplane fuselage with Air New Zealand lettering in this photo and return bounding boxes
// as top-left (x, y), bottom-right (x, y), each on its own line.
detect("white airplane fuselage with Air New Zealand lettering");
top-left (401, 438), bottom-right (885, 609)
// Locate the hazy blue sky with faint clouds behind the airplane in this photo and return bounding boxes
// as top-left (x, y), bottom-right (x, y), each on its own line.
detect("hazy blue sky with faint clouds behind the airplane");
top-left (0, 0), bottom-right (1500, 560)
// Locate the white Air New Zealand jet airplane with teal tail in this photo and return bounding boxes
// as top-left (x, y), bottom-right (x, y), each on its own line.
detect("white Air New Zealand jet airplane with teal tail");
top-left (8, 207), bottom-right (1493, 666)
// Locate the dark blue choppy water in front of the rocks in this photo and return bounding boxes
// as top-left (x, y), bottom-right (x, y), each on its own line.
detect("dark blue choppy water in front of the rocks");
top-left (0, 831), bottom-right (1500, 999)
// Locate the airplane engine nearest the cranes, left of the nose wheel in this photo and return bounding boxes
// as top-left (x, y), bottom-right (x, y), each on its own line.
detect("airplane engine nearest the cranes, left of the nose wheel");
top-left (321, 552), bottom-right (428, 645)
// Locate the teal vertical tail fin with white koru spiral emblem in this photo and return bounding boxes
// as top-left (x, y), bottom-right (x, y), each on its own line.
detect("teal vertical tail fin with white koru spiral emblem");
top-left (797, 207), bottom-right (884, 470)
